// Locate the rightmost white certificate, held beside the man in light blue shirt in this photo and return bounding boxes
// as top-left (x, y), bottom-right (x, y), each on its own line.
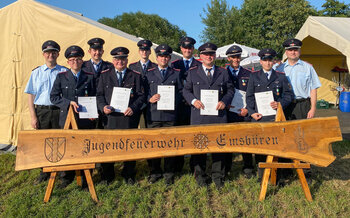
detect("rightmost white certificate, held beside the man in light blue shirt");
top-left (254, 91), bottom-right (276, 116)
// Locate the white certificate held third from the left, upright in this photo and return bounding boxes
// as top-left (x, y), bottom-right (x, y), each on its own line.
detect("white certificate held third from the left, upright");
top-left (157, 85), bottom-right (175, 110)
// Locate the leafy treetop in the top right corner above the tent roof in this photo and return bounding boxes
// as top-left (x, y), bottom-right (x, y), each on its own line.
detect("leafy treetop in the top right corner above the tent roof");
top-left (319, 0), bottom-right (350, 17)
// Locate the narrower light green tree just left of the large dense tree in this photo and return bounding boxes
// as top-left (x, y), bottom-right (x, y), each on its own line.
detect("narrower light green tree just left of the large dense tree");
top-left (201, 0), bottom-right (242, 46)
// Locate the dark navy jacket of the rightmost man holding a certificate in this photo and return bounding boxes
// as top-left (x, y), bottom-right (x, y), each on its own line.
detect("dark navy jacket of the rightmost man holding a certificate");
top-left (246, 69), bottom-right (293, 115)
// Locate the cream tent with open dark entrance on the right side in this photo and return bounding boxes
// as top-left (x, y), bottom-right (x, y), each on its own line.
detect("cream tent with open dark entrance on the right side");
top-left (284, 16), bottom-right (350, 103)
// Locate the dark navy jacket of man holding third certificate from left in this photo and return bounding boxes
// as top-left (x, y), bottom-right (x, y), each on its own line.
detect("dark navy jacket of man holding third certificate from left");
top-left (145, 67), bottom-right (183, 121)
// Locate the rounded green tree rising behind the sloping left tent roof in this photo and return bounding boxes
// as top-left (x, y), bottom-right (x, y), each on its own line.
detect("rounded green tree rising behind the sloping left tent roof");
top-left (98, 12), bottom-right (186, 52)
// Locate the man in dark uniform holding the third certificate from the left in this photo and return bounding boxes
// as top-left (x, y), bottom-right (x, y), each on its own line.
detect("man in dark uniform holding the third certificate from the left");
top-left (145, 44), bottom-right (183, 185)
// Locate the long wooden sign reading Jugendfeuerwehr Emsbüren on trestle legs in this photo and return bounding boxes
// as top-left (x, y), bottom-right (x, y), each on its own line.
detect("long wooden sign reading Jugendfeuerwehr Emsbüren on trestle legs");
top-left (16, 104), bottom-right (342, 202)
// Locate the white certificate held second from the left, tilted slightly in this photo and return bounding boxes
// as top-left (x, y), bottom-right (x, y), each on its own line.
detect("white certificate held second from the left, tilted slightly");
top-left (110, 87), bottom-right (131, 113)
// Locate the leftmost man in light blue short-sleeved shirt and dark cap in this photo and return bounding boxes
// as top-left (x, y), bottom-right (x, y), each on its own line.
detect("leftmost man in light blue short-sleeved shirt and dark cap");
top-left (24, 40), bottom-right (67, 182)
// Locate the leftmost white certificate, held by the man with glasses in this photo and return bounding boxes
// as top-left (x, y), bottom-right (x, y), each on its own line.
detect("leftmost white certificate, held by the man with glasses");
top-left (78, 97), bottom-right (98, 119)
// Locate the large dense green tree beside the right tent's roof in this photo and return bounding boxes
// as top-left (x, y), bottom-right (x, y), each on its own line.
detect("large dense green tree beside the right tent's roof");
top-left (241, 0), bottom-right (317, 56)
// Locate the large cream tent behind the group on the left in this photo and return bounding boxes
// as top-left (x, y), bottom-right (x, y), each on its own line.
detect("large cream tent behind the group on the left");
top-left (0, 0), bottom-right (180, 145)
